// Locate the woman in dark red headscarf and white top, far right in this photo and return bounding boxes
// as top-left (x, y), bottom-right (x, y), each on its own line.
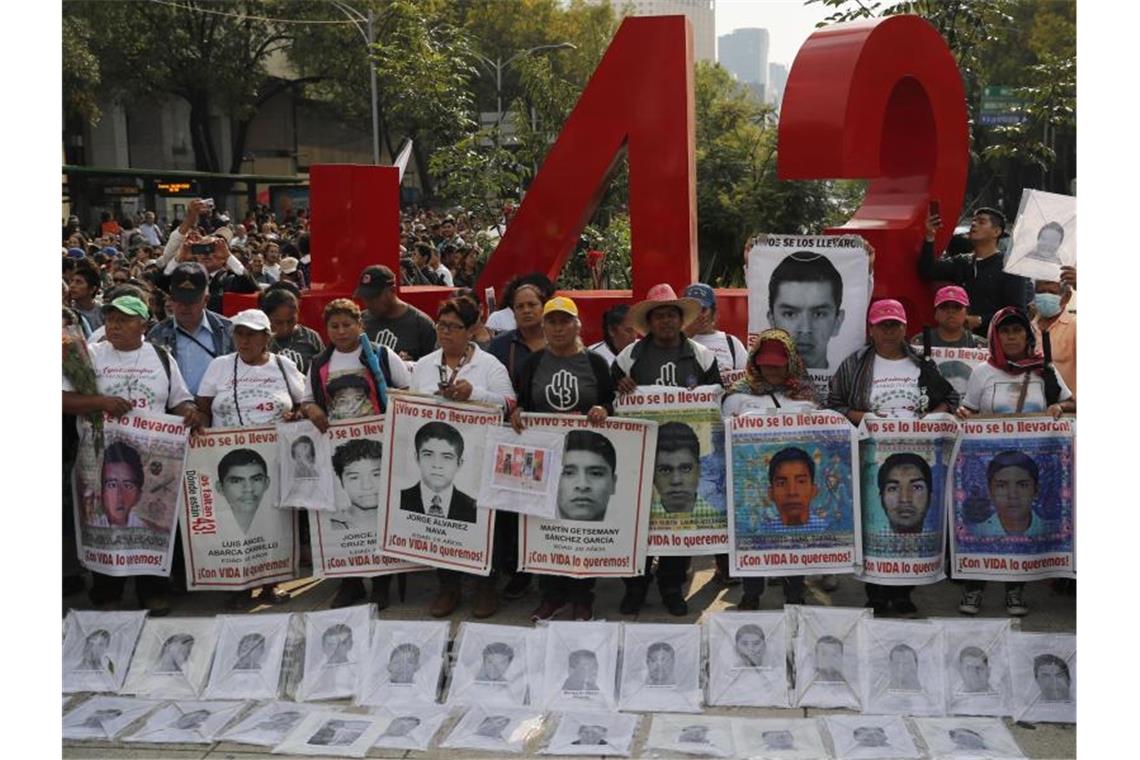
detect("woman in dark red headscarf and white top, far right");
top-left (958, 307), bottom-right (1076, 618)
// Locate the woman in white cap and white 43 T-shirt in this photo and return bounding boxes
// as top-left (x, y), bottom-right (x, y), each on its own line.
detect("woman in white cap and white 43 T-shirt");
top-left (196, 309), bottom-right (328, 607)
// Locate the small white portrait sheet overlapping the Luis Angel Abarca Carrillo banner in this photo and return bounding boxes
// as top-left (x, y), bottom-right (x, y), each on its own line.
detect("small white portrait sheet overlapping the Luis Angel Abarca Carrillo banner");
top-left (277, 419), bottom-right (334, 510)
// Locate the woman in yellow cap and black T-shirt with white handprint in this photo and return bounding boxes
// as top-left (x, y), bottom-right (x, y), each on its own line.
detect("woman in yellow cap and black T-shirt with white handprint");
top-left (511, 296), bottom-right (613, 622)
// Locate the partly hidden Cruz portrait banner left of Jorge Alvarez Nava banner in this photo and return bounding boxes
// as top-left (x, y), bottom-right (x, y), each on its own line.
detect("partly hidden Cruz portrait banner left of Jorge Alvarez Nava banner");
top-left (309, 417), bottom-right (426, 578)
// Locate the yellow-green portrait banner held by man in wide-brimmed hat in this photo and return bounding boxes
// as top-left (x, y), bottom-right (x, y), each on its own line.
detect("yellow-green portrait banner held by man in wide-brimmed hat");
top-left (613, 385), bottom-right (728, 557)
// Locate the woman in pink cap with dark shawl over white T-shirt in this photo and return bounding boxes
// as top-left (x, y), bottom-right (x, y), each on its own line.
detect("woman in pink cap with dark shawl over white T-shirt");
top-left (828, 299), bottom-right (958, 618)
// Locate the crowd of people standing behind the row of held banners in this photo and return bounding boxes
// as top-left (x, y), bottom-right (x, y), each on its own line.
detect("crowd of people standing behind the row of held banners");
top-left (63, 199), bottom-right (1076, 621)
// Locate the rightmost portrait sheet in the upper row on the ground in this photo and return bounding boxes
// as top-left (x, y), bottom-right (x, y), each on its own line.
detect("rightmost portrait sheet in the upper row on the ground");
top-left (1009, 631), bottom-right (1076, 724)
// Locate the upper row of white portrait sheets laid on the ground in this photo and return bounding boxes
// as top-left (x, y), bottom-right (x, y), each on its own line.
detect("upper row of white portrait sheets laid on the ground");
top-left (64, 605), bottom-right (1076, 722)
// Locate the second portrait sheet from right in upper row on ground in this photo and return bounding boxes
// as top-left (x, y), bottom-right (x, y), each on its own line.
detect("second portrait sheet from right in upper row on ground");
top-left (938, 618), bottom-right (1012, 716)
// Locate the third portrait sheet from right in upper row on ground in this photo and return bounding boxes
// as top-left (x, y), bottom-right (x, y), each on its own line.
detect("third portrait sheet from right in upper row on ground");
top-left (860, 619), bottom-right (946, 716)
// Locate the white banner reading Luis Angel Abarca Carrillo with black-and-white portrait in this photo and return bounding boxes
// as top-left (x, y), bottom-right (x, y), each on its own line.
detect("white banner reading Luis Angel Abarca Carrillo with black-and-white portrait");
top-left (179, 425), bottom-right (301, 590)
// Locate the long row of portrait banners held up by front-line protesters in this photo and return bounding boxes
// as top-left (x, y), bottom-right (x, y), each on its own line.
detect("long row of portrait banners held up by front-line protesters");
top-left (75, 387), bottom-right (1075, 589)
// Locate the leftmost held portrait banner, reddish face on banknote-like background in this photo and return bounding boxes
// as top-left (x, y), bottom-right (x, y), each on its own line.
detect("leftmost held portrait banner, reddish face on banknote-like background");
top-left (72, 412), bottom-right (188, 575)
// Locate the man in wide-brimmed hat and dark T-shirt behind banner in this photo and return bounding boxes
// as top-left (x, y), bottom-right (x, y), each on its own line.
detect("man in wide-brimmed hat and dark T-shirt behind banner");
top-left (611, 283), bottom-right (720, 615)
